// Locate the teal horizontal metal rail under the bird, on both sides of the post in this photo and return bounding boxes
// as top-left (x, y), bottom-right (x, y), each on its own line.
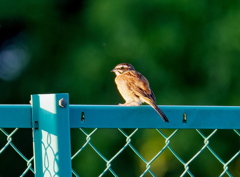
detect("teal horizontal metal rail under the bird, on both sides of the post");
top-left (0, 105), bottom-right (240, 129)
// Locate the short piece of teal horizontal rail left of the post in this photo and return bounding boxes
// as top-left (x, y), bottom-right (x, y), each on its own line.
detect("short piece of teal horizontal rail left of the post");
top-left (0, 104), bottom-right (32, 128)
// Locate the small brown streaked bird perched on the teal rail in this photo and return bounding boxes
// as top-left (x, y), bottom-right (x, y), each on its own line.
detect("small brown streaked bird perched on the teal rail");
top-left (111, 63), bottom-right (169, 122)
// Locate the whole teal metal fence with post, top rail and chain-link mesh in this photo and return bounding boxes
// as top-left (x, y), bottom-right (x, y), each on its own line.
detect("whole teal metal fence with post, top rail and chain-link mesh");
top-left (0, 94), bottom-right (240, 177)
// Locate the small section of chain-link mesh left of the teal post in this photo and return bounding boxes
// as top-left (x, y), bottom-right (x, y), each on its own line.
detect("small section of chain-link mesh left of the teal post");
top-left (0, 128), bottom-right (34, 177)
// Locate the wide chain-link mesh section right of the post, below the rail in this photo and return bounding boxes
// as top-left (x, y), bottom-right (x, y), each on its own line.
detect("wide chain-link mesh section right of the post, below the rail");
top-left (72, 128), bottom-right (240, 177)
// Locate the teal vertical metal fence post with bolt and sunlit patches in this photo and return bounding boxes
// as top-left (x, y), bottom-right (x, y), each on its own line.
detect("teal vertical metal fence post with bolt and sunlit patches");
top-left (31, 94), bottom-right (72, 177)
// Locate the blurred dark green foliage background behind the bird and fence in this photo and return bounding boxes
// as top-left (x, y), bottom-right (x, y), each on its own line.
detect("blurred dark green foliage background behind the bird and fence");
top-left (0, 0), bottom-right (240, 177)
